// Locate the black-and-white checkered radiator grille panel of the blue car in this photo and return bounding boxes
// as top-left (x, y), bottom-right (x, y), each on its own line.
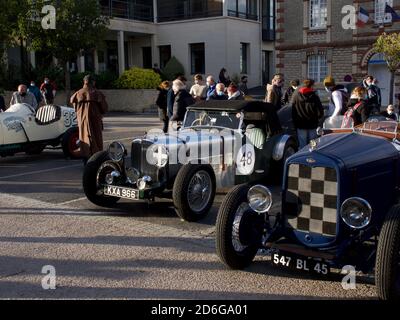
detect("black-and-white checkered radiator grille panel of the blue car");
top-left (284, 164), bottom-right (338, 237)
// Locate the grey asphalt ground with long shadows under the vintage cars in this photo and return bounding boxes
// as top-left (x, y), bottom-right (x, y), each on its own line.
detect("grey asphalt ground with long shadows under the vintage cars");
top-left (0, 115), bottom-right (376, 300)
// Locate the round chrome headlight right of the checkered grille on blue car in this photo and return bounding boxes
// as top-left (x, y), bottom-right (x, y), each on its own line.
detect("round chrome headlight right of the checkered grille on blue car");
top-left (340, 198), bottom-right (372, 229)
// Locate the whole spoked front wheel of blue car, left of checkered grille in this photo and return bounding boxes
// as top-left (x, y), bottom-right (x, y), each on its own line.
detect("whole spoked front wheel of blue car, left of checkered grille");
top-left (216, 185), bottom-right (264, 270)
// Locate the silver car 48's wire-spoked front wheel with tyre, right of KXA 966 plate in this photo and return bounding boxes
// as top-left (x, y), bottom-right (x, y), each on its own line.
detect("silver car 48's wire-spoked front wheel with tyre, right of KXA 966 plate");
top-left (172, 164), bottom-right (216, 222)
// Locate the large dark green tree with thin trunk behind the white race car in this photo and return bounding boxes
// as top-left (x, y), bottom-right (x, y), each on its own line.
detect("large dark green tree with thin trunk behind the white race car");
top-left (18, 0), bottom-right (109, 99)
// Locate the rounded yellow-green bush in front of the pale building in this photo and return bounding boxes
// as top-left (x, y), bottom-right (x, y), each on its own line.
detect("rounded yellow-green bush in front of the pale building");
top-left (115, 67), bottom-right (161, 89)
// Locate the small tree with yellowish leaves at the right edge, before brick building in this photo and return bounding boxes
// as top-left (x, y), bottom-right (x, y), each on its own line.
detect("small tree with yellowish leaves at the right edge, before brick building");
top-left (374, 32), bottom-right (400, 104)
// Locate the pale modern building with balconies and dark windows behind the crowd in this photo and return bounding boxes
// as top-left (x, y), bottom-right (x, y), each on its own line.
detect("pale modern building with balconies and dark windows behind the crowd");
top-left (23, 0), bottom-right (276, 86)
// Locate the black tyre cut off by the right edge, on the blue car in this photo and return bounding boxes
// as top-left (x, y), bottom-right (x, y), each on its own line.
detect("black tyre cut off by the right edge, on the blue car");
top-left (375, 205), bottom-right (400, 300)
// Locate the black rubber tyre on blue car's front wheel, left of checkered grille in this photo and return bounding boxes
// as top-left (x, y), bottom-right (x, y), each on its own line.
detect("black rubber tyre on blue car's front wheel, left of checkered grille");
top-left (216, 185), bottom-right (263, 270)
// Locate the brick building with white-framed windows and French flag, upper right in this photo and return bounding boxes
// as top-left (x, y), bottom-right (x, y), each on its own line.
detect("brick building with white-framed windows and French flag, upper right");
top-left (276, 0), bottom-right (400, 104)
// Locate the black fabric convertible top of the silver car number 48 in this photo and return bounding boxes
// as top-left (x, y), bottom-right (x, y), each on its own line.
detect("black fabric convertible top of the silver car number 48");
top-left (187, 100), bottom-right (282, 135)
